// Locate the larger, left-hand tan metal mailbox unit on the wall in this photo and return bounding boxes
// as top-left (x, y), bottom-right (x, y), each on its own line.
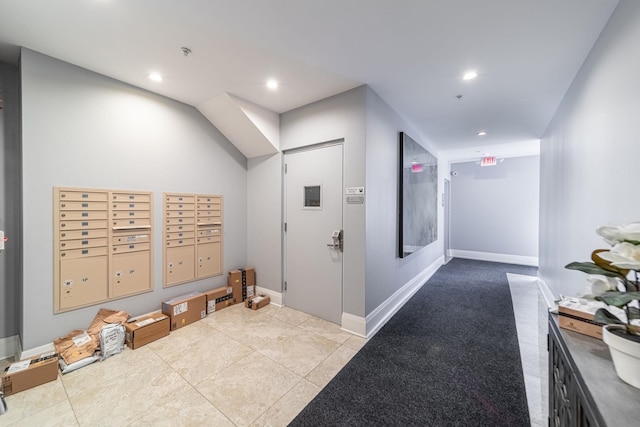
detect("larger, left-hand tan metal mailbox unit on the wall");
top-left (54, 187), bottom-right (153, 313)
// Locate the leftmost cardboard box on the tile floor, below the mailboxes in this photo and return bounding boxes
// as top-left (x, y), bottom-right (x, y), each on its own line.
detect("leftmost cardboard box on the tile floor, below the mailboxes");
top-left (2, 354), bottom-right (58, 396)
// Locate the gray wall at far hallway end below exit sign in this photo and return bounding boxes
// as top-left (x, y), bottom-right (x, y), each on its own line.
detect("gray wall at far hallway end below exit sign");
top-left (450, 156), bottom-right (540, 257)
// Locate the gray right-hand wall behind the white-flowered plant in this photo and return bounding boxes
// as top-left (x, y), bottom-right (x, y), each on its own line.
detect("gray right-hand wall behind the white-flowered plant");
top-left (539, 0), bottom-right (640, 296)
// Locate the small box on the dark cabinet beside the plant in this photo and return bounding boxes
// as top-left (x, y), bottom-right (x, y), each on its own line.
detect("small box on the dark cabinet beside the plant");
top-left (558, 298), bottom-right (606, 339)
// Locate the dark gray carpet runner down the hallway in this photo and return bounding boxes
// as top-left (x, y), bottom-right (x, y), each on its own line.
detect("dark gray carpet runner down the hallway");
top-left (290, 259), bottom-right (536, 426)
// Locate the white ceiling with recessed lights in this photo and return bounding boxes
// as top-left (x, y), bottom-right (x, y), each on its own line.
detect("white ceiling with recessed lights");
top-left (0, 0), bottom-right (618, 158)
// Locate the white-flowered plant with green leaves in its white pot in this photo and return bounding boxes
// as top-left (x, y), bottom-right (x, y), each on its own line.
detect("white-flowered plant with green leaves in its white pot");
top-left (565, 222), bottom-right (640, 388)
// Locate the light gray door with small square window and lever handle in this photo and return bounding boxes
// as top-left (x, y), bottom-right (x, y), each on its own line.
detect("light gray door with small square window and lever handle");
top-left (284, 144), bottom-right (343, 324)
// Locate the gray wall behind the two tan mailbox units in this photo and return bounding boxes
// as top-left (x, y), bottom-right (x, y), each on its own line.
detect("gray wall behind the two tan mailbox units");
top-left (21, 49), bottom-right (247, 349)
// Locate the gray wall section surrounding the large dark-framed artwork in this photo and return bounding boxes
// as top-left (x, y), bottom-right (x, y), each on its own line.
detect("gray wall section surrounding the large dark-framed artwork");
top-left (365, 89), bottom-right (446, 314)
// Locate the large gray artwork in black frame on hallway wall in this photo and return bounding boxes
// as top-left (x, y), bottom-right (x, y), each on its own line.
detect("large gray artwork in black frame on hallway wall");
top-left (398, 132), bottom-right (438, 258)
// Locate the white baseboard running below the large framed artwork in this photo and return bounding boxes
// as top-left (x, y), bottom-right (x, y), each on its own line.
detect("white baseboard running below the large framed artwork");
top-left (360, 255), bottom-right (444, 338)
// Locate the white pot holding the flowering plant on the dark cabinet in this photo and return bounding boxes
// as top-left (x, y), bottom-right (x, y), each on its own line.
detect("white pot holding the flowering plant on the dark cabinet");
top-left (602, 325), bottom-right (640, 388)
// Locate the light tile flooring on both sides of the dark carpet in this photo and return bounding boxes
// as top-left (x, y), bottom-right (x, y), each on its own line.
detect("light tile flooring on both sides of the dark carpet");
top-left (0, 275), bottom-right (548, 427)
